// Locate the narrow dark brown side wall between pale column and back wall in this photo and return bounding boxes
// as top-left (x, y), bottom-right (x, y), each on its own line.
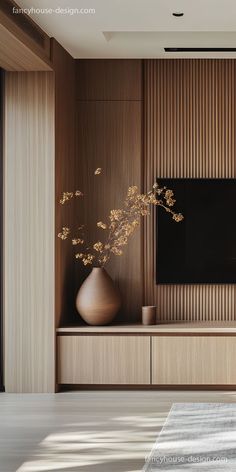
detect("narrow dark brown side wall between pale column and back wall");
top-left (52, 39), bottom-right (77, 326)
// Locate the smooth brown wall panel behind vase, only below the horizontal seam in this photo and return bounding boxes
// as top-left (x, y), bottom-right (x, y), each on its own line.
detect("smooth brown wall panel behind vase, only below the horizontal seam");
top-left (76, 101), bottom-right (142, 321)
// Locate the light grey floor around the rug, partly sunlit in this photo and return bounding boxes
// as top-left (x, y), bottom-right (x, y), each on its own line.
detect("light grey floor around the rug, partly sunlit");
top-left (0, 391), bottom-right (236, 472)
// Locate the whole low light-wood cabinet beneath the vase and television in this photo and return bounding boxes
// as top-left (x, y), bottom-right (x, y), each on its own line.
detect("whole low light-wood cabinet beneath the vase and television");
top-left (57, 323), bottom-right (236, 388)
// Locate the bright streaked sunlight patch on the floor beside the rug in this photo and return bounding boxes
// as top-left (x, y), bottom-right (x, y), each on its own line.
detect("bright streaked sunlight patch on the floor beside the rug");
top-left (14, 414), bottom-right (162, 472)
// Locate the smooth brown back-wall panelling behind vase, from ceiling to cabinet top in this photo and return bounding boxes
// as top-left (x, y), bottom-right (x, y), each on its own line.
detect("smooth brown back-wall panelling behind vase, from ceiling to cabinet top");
top-left (76, 60), bottom-right (142, 321)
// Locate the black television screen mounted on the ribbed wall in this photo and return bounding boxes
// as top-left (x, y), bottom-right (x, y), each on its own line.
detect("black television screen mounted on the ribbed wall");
top-left (156, 179), bottom-right (236, 284)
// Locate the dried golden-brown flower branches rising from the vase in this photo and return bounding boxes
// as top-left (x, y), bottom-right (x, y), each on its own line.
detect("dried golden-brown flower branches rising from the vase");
top-left (58, 167), bottom-right (184, 267)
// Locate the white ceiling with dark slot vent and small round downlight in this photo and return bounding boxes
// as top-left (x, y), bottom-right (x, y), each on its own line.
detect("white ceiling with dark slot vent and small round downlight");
top-left (17, 0), bottom-right (236, 58)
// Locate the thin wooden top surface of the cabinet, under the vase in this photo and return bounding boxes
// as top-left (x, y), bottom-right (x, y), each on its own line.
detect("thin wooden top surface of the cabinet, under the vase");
top-left (57, 321), bottom-right (236, 334)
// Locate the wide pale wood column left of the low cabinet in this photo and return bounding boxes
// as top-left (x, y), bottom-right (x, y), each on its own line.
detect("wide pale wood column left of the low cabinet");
top-left (4, 72), bottom-right (55, 393)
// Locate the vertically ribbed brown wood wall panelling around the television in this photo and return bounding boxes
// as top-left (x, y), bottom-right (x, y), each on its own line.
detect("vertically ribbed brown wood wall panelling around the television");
top-left (144, 59), bottom-right (236, 321)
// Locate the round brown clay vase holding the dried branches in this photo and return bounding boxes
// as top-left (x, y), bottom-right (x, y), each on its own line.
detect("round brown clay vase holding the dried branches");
top-left (76, 267), bottom-right (121, 326)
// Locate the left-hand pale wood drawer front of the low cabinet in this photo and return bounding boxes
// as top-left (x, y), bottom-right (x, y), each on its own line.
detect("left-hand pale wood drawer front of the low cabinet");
top-left (58, 336), bottom-right (150, 385)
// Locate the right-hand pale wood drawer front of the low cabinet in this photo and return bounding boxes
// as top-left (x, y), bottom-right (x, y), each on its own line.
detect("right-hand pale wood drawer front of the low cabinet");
top-left (152, 336), bottom-right (236, 385)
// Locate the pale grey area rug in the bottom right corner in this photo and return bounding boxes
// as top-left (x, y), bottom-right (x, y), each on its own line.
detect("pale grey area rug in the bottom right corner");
top-left (143, 403), bottom-right (236, 472)
